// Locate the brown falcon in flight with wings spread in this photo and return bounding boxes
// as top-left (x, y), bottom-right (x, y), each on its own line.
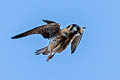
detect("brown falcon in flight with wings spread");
top-left (11, 19), bottom-right (86, 61)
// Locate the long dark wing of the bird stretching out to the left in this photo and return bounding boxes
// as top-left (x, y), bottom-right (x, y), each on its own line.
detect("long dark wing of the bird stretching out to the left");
top-left (12, 20), bottom-right (60, 39)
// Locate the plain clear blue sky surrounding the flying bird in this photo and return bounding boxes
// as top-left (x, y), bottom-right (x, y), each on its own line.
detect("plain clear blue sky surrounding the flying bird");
top-left (0, 0), bottom-right (120, 80)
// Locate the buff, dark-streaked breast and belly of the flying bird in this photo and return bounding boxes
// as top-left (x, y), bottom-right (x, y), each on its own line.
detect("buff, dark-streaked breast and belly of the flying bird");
top-left (49, 31), bottom-right (72, 53)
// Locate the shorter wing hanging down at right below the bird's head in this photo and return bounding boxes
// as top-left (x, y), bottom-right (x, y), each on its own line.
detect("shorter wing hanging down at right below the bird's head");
top-left (71, 33), bottom-right (82, 53)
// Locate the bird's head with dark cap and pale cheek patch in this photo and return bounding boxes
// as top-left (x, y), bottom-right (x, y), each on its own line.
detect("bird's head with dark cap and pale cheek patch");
top-left (67, 24), bottom-right (86, 33)
